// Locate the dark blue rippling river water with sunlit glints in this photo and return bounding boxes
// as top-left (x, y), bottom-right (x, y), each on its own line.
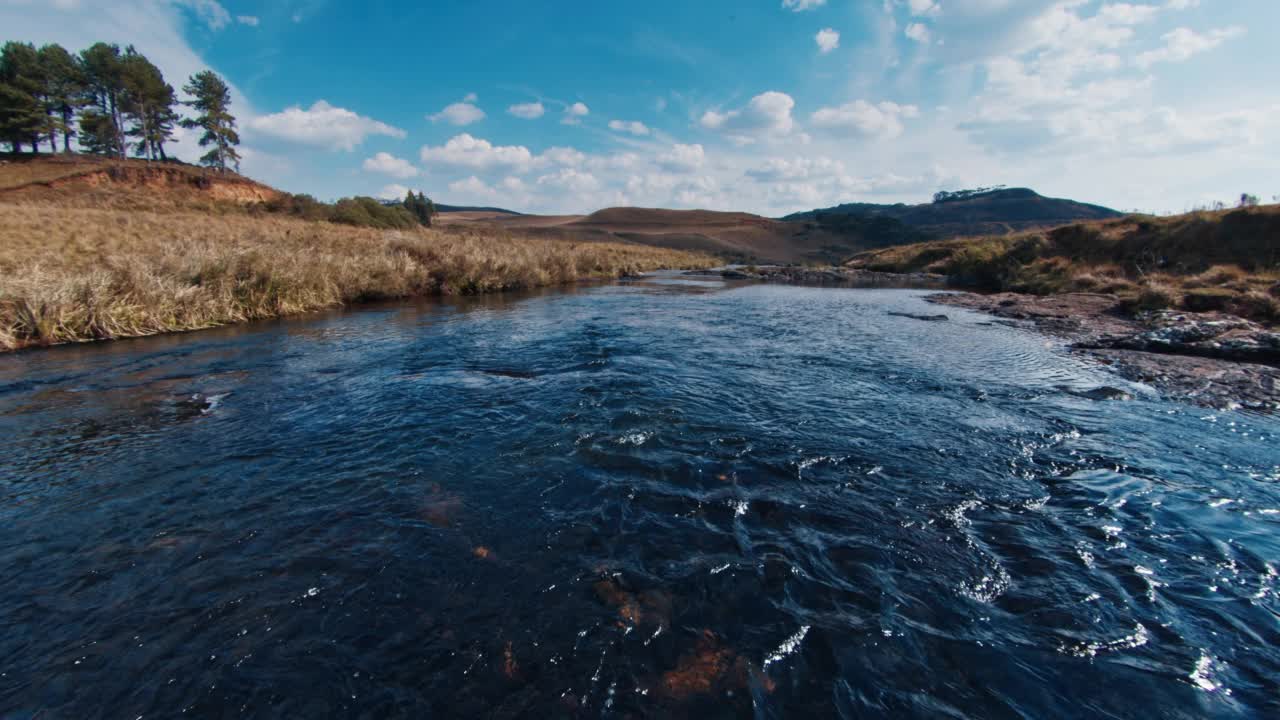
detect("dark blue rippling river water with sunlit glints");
top-left (0, 277), bottom-right (1280, 719)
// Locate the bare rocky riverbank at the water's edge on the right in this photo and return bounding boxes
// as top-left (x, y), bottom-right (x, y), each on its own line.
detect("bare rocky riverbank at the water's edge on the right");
top-left (929, 288), bottom-right (1280, 411)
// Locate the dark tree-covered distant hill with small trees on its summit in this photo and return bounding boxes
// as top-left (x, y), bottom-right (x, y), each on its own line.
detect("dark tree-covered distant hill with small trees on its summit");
top-left (782, 187), bottom-right (1123, 238)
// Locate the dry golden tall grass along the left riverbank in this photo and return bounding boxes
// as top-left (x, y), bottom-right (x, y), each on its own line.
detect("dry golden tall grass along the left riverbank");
top-left (0, 204), bottom-right (717, 350)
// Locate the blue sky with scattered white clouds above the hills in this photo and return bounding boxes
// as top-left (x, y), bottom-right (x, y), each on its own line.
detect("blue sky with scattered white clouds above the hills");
top-left (0, 0), bottom-right (1280, 215)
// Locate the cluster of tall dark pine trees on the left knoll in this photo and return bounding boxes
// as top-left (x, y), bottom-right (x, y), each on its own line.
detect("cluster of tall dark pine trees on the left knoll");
top-left (0, 41), bottom-right (241, 172)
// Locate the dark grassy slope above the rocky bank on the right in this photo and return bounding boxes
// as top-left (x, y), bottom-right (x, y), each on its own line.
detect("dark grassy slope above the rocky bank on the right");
top-left (849, 205), bottom-right (1280, 322)
